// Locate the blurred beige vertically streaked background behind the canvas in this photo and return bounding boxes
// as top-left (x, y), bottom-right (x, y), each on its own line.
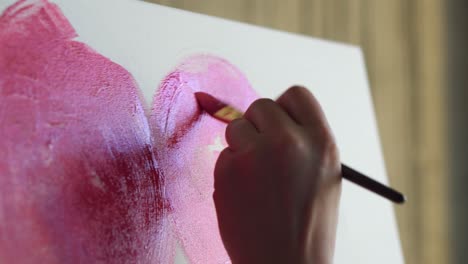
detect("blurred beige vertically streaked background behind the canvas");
top-left (145, 0), bottom-right (460, 264)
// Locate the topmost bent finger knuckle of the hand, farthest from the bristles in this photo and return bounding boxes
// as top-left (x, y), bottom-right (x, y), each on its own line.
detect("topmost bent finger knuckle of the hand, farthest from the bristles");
top-left (276, 86), bottom-right (328, 127)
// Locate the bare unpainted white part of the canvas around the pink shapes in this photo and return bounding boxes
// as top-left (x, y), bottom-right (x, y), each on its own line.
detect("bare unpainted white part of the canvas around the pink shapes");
top-left (0, 0), bottom-right (403, 264)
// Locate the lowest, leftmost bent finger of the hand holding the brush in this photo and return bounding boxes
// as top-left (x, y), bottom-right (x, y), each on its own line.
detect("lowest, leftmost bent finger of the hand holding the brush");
top-left (226, 118), bottom-right (258, 150)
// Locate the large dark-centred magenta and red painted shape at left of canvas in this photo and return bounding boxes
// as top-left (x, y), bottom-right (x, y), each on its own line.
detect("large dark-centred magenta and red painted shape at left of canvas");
top-left (0, 0), bottom-right (174, 263)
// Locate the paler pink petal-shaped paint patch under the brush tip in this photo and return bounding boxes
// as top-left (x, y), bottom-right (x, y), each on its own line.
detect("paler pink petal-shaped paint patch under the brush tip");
top-left (151, 55), bottom-right (257, 263)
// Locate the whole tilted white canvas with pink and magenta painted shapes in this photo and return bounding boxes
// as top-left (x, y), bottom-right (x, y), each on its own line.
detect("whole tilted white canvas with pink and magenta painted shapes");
top-left (0, 0), bottom-right (403, 263)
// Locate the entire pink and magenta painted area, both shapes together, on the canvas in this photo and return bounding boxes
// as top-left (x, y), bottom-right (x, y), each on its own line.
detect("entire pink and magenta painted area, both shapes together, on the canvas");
top-left (0, 0), bottom-right (257, 264)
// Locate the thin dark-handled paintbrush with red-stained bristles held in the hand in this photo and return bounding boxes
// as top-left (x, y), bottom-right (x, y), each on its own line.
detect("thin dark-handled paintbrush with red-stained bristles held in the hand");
top-left (195, 92), bottom-right (406, 204)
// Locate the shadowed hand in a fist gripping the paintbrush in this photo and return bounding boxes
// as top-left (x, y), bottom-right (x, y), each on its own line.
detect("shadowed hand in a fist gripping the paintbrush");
top-left (213, 86), bottom-right (341, 264)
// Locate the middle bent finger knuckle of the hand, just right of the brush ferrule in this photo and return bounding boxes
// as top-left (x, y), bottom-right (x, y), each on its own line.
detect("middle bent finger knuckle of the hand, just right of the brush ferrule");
top-left (244, 99), bottom-right (294, 133)
